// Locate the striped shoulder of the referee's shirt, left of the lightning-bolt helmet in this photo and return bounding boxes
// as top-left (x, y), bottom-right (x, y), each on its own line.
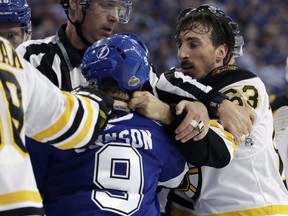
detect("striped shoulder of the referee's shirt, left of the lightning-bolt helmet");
top-left (16, 24), bottom-right (85, 91)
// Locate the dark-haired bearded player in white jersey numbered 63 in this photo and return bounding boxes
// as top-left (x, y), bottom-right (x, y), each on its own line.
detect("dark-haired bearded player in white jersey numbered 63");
top-left (156, 5), bottom-right (288, 216)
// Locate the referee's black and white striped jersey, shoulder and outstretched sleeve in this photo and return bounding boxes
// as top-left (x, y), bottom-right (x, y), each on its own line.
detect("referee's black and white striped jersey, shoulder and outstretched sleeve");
top-left (16, 24), bottom-right (223, 106)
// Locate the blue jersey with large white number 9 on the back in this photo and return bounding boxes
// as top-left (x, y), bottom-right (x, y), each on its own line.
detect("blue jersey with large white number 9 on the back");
top-left (29, 113), bottom-right (187, 216)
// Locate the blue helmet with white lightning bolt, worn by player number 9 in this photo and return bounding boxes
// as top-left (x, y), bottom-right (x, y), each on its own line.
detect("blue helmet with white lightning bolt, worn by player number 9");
top-left (81, 34), bottom-right (151, 92)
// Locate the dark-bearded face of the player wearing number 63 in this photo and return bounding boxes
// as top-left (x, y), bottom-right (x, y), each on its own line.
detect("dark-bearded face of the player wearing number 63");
top-left (177, 23), bottom-right (225, 80)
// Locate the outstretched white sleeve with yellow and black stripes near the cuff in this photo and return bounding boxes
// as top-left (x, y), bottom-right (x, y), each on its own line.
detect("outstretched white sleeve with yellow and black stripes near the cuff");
top-left (23, 58), bottom-right (99, 149)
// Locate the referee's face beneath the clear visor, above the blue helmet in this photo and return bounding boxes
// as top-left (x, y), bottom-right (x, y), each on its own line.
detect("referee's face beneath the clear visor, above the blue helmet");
top-left (82, 0), bottom-right (121, 43)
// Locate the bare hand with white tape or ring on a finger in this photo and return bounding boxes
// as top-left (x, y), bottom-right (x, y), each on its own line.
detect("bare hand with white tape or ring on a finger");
top-left (175, 100), bottom-right (210, 143)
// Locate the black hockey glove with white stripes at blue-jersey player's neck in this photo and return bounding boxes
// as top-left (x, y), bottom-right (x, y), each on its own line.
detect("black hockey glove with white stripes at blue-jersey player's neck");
top-left (71, 81), bottom-right (114, 128)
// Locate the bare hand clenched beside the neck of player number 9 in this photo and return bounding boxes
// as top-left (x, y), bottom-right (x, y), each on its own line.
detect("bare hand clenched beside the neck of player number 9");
top-left (128, 91), bottom-right (173, 124)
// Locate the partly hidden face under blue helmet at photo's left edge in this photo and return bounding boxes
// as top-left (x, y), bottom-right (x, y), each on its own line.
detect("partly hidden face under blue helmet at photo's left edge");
top-left (0, 24), bottom-right (27, 48)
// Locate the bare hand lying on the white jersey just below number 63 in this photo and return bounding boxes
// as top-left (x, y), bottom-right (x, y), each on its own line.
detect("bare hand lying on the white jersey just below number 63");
top-left (217, 100), bottom-right (257, 145)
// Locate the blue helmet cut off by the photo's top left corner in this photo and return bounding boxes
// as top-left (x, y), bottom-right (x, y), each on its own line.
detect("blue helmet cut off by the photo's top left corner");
top-left (0, 0), bottom-right (32, 32)
